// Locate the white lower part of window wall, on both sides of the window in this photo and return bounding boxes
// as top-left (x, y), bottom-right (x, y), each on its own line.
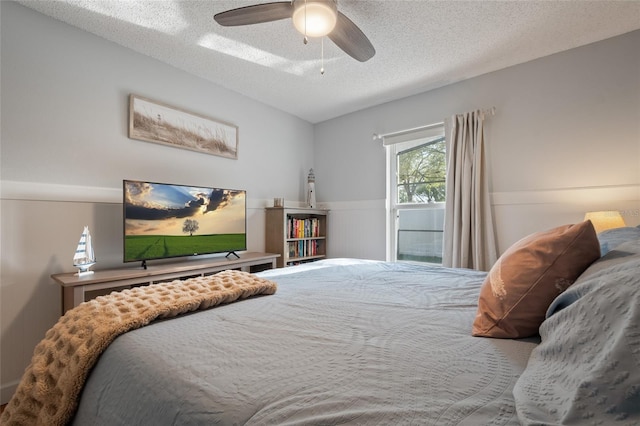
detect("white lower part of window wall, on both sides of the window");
top-left (320, 184), bottom-right (640, 260)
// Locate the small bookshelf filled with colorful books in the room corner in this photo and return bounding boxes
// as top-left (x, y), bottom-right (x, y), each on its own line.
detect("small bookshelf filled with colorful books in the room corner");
top-left (265, 207), bottom-right (329, 268)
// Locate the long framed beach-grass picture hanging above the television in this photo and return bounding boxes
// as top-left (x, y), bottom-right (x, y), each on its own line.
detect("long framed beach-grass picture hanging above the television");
top-left (129, 94), bottom-right (239, 160)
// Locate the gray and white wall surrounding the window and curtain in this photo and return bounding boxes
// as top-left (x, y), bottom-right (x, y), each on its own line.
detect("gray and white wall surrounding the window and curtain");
top-left (315, 31), bottom-right (640, 259)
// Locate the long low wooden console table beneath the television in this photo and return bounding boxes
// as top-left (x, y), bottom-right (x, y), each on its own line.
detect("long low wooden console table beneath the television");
top-left (51, 252), bottom-right (280, 313)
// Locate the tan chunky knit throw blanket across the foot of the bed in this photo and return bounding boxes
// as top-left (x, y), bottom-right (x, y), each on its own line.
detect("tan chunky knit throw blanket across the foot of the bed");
top-left (0, 271), bottom-right (277, 426)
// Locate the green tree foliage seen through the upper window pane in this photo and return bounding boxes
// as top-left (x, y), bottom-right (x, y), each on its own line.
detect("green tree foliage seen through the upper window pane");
top-left (398, 140), bottom-right (446, 203)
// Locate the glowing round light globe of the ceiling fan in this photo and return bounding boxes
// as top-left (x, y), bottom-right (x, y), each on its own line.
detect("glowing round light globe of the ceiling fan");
top-left (291, 0), bottom-right (338, 37)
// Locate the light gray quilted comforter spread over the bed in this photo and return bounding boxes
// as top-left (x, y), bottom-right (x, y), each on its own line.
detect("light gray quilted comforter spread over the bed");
top-left (75, 260), bottom-right (537, 425)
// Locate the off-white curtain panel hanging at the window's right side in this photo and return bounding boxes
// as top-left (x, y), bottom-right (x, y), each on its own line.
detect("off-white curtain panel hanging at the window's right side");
top-left (442, 111), bottom-right (497, 271)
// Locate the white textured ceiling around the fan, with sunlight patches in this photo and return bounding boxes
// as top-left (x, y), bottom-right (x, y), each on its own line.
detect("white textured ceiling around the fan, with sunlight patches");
top-left (19, 0), bottom-right (640, 123)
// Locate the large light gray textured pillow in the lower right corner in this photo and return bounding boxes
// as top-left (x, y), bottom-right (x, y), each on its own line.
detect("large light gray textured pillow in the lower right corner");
top-left (513, 239), bottom-right (640, 425)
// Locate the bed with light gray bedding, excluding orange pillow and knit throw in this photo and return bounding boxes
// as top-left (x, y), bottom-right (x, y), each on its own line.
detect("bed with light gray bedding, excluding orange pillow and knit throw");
top-left (2, 228), bottom-right (640, 425)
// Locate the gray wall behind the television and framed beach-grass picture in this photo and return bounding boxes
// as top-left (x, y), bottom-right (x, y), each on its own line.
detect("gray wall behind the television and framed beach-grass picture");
top-left (0, 1), bottom-right (313, 402)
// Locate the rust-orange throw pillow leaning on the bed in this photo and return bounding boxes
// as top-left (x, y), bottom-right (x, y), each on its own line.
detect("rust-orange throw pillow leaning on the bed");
top-left (472, 221), bottom-right (600, 338)
